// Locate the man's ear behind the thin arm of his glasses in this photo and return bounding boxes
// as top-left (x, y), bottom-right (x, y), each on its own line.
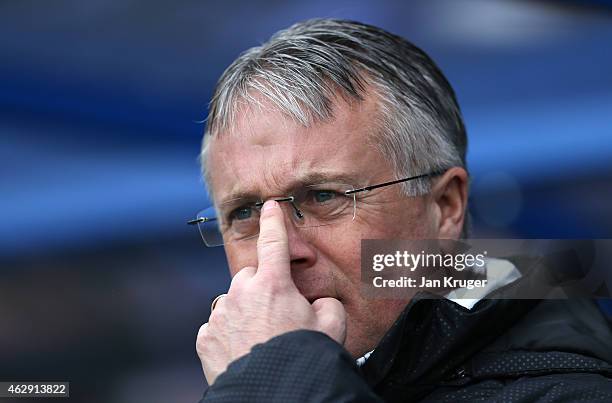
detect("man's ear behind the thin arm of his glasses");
top-left (430, 167), bottom-right (469, 239)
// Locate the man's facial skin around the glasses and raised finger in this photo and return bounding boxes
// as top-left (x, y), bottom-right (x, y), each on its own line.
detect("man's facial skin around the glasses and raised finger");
top-left (208, 92), bottom-right (438, 357)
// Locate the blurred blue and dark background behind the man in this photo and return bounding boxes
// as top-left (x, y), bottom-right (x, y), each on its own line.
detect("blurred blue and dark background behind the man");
top-left (0, 0), bottom-right (612, 403)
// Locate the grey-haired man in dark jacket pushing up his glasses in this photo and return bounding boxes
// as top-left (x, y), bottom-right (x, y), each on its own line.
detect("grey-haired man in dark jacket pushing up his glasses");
top-left (194, 20), bottom-right (612, 402)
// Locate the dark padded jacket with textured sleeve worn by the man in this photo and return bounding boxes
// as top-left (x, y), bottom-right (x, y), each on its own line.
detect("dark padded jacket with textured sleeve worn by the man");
top-left (202, 262), bottom-right (612, 403)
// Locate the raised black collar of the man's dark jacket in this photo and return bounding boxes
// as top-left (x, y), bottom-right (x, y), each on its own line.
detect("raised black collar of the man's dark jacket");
top-left (361, 259), bottom-right (544, 396)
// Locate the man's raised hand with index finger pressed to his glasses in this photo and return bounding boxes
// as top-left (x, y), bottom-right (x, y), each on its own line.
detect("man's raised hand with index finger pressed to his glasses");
top-left (196, 200), bottom-right (346, 385)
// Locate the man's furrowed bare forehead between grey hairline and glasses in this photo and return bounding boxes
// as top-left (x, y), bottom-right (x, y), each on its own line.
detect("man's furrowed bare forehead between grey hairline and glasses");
top-left (207, 93), bottom-right (388, 205)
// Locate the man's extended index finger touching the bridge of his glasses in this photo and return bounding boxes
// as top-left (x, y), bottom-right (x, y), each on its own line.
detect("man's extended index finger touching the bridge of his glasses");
top-left (257, 200), bottom-right (291, 280)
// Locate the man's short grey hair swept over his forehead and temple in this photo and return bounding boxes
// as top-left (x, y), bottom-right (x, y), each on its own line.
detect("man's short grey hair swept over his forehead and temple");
top-left (201, 19), bottom-right (467, 232)
